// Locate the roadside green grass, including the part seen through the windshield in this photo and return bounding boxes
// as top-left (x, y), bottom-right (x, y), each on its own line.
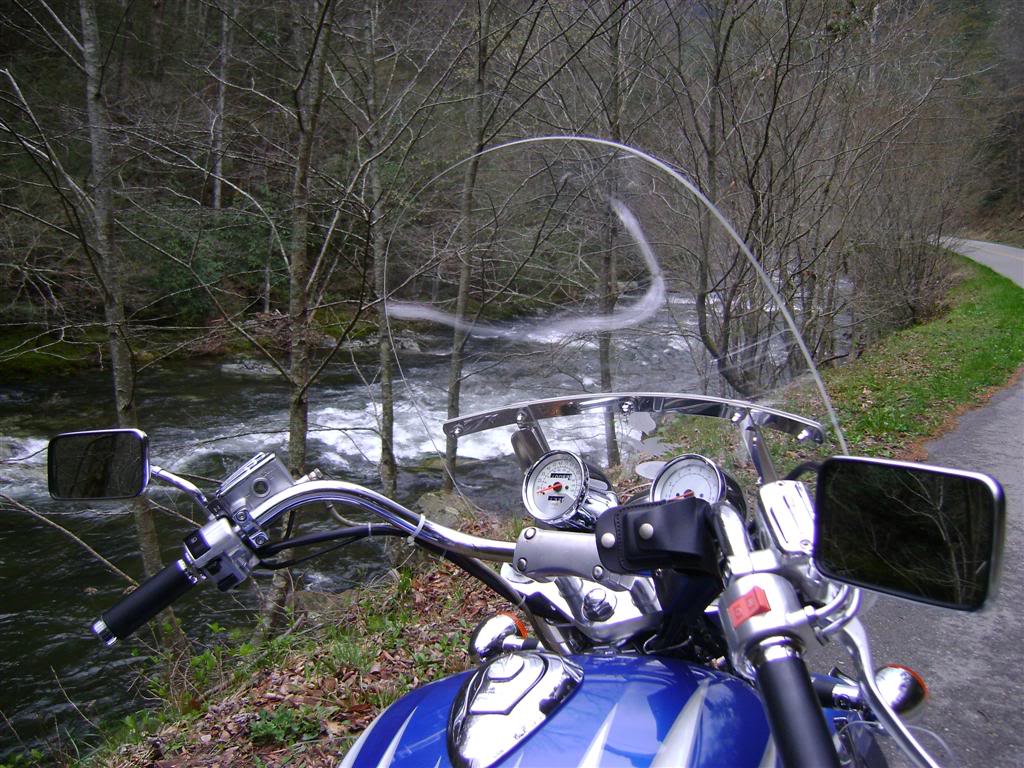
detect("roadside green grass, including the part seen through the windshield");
top-left (664, 255), bottom-right (1024, 479)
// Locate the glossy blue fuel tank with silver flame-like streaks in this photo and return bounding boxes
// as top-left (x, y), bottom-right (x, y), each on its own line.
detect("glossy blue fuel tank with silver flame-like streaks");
top-left (341, 655), bottom-right (776, 768)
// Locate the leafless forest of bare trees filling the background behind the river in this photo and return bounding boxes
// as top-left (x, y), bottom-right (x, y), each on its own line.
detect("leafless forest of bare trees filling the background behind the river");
top-left (0, 0), bottom-right (1024, 761)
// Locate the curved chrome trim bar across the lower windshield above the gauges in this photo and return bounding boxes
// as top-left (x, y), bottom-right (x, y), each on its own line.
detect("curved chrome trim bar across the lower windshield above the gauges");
top-left (444, 392), bottom-right (824, 443)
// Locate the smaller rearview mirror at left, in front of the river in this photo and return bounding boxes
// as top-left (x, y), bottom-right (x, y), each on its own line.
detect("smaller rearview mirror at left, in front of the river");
top-left (46, 429), bottom-right (150, 500)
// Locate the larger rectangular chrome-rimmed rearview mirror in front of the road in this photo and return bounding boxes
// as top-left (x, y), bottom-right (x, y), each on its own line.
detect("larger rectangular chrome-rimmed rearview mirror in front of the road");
top-left (814, 457), bottom-right (1005, 610)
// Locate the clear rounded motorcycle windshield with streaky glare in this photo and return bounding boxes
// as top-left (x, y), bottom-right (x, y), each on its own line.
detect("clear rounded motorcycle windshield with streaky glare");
top-left (383, 138), bottom-right (844, 512)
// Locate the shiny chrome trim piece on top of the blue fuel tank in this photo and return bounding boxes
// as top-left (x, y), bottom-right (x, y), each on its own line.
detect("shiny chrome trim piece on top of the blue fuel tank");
top-left (447, 651), bottom-right (583, 768)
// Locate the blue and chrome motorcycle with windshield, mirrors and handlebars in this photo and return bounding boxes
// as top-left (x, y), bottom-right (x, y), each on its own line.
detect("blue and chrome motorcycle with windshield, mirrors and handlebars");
top-left (48, 137), bottom-right (1005, 768)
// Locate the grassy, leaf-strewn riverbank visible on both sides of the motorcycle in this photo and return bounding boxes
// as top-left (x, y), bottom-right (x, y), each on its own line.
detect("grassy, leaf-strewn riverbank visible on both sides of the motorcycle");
top-left (6, 253), bottom-right (1024, 768)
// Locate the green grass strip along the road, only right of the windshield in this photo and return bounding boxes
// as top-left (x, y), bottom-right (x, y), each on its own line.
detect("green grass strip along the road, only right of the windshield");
top-left (825, 257), bottom-right (1024, 456)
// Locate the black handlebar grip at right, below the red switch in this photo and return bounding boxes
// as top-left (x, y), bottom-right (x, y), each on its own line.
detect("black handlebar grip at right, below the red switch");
top-left (752, 644), bottom-right (840, 768)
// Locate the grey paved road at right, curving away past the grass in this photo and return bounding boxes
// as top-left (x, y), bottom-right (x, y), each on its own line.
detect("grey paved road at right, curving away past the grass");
top-left (851, 241), bottom-right (1024, 768)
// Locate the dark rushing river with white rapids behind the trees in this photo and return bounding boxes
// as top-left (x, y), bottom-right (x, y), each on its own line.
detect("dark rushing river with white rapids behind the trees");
top-left (0, 309), bottom-right (712, 760)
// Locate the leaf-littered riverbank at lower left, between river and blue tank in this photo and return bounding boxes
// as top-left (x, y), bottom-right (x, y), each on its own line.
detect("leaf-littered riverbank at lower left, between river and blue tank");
top-left (12, 518), bottom-right (514, 768)
